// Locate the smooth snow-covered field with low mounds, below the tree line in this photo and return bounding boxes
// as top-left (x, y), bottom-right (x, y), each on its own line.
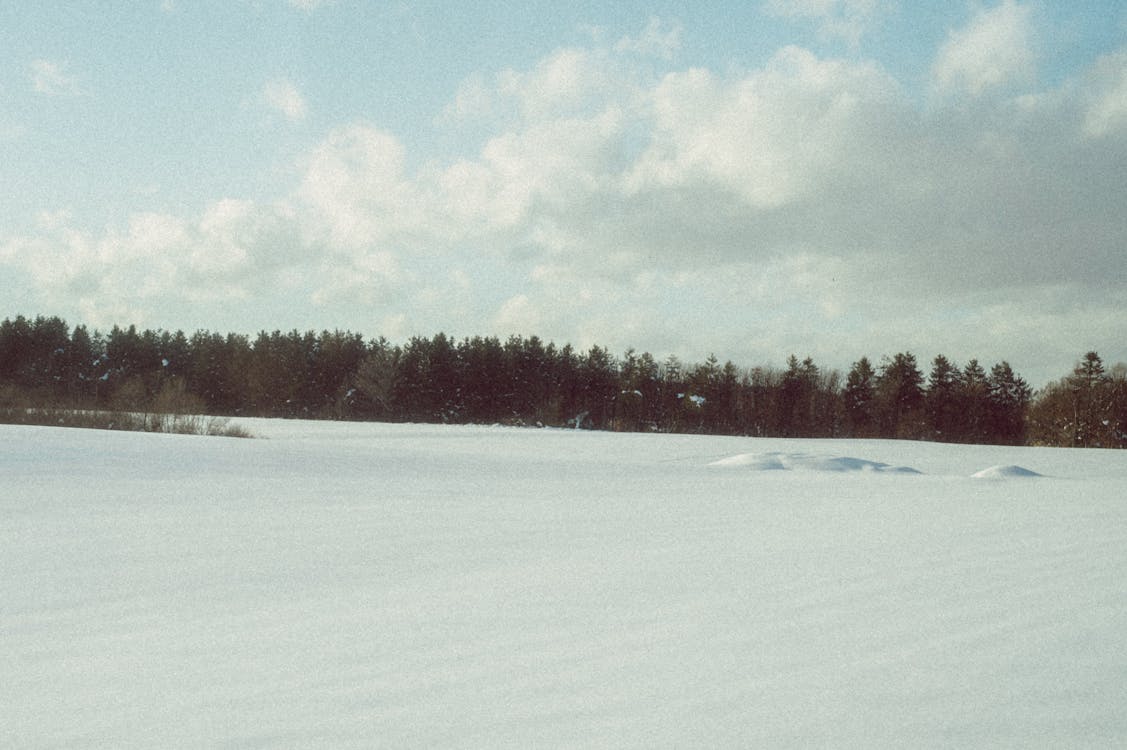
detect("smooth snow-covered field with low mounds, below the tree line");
top-left (0, 420), bottom-right (1127, 748)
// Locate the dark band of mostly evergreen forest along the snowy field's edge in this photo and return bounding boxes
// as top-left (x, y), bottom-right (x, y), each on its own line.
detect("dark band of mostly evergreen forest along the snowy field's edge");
top-left (0, 316), bottom-right (1127, 448)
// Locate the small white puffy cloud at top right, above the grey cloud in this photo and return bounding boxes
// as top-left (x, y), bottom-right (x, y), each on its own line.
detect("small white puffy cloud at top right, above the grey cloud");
top-left (932, 0), bottom-right (1033, 96)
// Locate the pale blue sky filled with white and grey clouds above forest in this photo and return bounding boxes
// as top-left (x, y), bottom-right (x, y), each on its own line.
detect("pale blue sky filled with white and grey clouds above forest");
top-left (0, 0), bottom-right (1127, 387)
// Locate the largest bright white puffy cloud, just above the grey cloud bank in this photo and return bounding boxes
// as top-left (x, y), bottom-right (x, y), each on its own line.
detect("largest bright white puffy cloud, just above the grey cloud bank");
top-left (630, 47), bottom-right (903, 208)
